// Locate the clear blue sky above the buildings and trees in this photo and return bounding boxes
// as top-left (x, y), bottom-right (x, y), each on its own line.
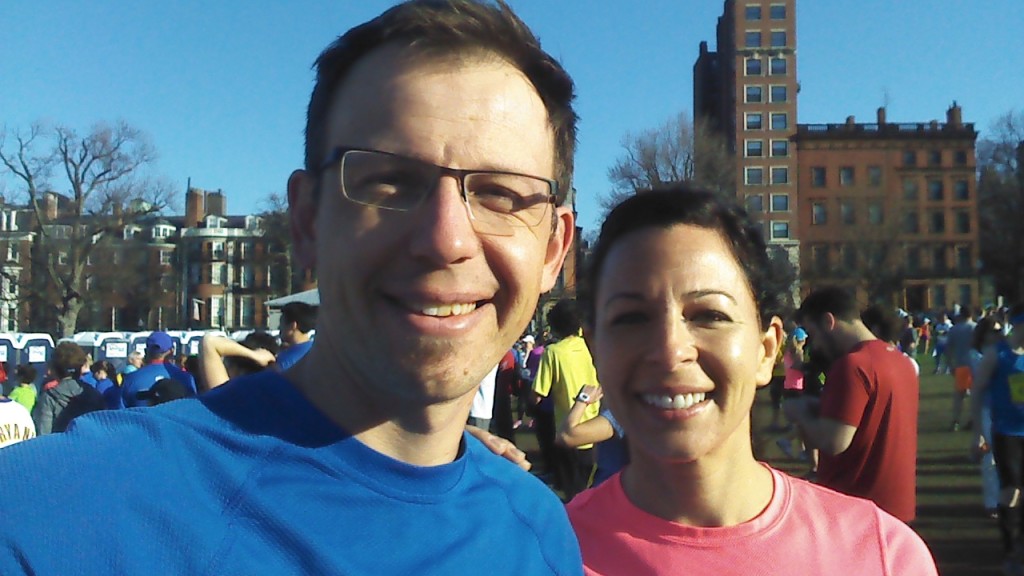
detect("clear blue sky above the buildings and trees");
top-left (0, 0), bottom-right (1024, 230)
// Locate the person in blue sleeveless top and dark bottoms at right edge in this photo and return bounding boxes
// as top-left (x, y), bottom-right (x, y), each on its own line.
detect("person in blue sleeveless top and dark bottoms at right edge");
top-left (971, 303), bottom-right (1024, 574)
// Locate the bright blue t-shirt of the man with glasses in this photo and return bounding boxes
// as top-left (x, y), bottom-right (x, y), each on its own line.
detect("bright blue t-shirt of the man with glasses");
top-left (0, 371), bottom-right (583, 576)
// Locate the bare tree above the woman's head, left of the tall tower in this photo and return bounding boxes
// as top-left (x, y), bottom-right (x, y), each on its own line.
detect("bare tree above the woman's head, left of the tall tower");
top-left (601, 112), bottom-right (735, 211)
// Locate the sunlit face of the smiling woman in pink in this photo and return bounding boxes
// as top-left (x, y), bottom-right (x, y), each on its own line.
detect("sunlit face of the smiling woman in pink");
top-left (591, 224), bottom-right (781, 461)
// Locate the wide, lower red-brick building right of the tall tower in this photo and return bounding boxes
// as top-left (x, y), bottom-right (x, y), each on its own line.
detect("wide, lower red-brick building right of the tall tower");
top-left (795, 104), bottom-right (980, 311)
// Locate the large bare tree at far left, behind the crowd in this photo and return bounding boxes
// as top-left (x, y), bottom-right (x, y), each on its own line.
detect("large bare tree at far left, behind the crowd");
top-left (0, 122), bottom-right (173, 336)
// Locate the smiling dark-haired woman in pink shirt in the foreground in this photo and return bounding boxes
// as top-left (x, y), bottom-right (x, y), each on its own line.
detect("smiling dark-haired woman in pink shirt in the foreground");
top-left (567, 188), bottom-right (937, 576)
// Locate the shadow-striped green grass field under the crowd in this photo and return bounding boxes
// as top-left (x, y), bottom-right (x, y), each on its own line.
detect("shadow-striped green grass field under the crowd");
top-left (516, 352), bottom-right (1001, 576)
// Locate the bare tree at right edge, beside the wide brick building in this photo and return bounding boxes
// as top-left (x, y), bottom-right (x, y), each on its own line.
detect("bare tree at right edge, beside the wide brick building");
top-left (977, 111), bottom-right (1024, 301)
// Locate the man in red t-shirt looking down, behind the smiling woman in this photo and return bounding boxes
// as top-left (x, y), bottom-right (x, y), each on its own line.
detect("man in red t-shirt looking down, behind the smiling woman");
top-left (785, 287), bottom-right (920, 522)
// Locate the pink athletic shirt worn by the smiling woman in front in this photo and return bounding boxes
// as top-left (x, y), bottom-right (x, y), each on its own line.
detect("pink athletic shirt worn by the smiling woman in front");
top-left (567, 463), bottom-right (938, 576)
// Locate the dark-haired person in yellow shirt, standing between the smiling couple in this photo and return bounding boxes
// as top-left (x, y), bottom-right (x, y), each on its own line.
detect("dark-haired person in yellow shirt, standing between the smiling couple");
top-left (534, 299), bottom-right (601, 501)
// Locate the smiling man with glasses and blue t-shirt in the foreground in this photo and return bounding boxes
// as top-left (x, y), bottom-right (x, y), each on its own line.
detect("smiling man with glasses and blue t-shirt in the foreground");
top-left (0, 0), bottom-right (582, 574)
